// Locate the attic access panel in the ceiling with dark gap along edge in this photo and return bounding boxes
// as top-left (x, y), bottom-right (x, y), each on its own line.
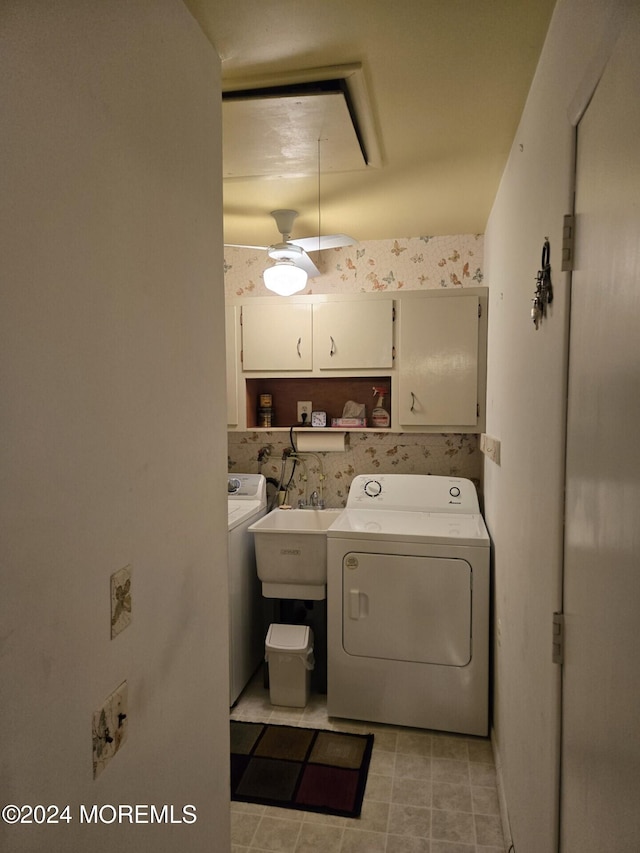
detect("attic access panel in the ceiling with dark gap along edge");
top-left (222, 80), bottom-right (367, 178)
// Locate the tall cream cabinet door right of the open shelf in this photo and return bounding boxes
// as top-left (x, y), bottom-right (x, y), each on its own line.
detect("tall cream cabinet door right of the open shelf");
top-left (398, 295), bottom-right (478, 426)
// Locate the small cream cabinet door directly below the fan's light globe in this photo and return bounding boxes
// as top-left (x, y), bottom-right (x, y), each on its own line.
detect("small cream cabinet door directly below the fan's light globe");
top-left (242, 302), bottom-right (313, 371)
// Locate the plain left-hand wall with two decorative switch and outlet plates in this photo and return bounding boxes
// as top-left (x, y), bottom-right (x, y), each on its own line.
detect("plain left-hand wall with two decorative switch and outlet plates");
top-left (0, 0), bottom-right (230, 853)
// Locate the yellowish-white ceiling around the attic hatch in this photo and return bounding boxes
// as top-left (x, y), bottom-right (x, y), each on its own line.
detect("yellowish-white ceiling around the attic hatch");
top-left (185, 0), bottom-right (555, 250)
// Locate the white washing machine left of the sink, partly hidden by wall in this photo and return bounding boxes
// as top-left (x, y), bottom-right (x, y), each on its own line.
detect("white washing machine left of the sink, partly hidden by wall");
top-left (227, 474), bottom-right (267, 706)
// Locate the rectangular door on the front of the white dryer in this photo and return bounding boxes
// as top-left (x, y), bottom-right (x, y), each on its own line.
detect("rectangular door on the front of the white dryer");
top-left (342, 551), bottom-right (473, 666)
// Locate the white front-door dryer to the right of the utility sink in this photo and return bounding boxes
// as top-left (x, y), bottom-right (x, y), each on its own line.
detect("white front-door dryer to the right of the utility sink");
top-left (327, 474), bottom-right (490, 735)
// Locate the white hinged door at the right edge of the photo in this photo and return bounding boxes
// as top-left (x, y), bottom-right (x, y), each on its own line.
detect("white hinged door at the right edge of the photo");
top-left (560, 5), bottom-right (640, 853)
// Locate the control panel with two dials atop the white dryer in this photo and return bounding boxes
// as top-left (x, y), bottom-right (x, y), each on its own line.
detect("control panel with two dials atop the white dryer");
top-left (347, 474), bottom-right (480, 514)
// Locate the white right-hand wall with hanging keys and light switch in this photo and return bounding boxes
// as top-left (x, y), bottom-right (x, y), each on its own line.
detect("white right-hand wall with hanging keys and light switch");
top-left (484, 0), bottom-right (615, 853)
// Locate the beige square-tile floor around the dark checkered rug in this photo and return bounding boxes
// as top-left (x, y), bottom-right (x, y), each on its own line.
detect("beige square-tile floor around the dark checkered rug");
top-left (231, 673), bottom-right (505, 853)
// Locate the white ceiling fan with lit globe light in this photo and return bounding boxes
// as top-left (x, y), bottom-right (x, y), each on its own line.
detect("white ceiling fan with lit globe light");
top-left (225, 210), bottom-right (357, 296)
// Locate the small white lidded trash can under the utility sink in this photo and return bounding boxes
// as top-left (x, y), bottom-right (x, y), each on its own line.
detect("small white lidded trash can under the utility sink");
top-left (264, 623), bottom-right (314, 708)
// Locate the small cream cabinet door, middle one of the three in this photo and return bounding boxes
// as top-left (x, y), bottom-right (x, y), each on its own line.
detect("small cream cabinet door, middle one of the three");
top-left (313, 299), bottom-right (393, 370)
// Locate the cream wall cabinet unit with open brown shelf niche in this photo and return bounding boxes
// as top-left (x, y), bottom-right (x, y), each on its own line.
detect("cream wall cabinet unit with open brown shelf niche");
top-left (232, 287), bottom-right (488, 433)
